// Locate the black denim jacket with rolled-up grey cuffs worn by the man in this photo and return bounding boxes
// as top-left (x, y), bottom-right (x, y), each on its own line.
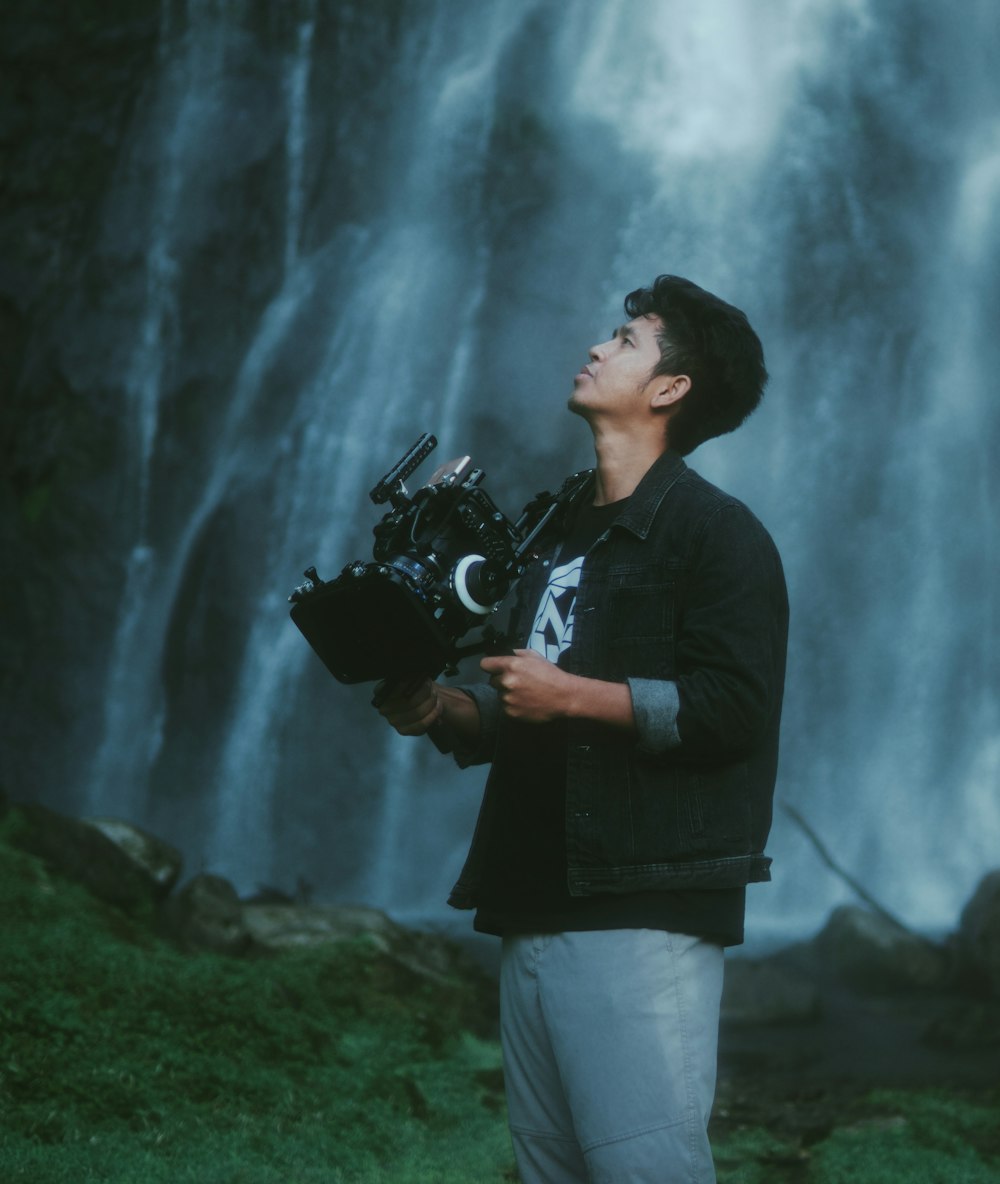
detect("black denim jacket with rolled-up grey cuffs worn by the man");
top-left (450, 452), bottom-right (788, 908)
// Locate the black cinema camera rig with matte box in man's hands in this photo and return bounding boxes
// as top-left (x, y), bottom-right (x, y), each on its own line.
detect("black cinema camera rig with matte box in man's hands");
top-left (289, 432), bottom-right (588, 683)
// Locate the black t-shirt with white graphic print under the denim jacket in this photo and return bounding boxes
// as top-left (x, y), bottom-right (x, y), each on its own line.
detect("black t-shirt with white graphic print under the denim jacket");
top-left (475, 502), bottom-right (746, 945)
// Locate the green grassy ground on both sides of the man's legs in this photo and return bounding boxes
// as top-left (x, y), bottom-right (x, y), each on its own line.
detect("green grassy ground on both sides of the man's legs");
top-left (0, 816), bottom-right (1000, 1184)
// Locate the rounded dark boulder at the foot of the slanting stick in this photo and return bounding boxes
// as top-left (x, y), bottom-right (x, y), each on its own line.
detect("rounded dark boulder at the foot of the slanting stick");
top-left (813, 905), bottom-right (951, 995)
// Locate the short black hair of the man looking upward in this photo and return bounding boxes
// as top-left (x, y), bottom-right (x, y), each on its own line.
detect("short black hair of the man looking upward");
top-left (625, 276), bottom-right (767, 456)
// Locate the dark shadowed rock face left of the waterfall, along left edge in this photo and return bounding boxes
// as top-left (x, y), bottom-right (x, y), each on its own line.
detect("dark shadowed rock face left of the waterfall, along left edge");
top-left (0, 0), bottom-right (160, 805)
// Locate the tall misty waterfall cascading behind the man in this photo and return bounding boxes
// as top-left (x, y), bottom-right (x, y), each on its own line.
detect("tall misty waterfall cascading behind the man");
top-left (64, 0), bottom-right (1000, 934)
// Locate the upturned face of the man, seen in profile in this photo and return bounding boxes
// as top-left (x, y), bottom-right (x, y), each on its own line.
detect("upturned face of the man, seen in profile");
top-left (569, 316), bottom-right (663, 419)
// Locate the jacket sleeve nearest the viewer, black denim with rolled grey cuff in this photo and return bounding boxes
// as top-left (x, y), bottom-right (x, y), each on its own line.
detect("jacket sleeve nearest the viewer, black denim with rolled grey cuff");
top-left (628, 503), bottom-right (788, 762)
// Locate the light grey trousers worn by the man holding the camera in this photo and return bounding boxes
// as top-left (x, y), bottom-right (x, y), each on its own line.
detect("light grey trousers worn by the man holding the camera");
top-left (501, 929), bottom-right (723, 1184)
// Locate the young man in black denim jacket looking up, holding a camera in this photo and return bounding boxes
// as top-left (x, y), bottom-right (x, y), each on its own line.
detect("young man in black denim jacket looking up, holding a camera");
top-left (380, 276), bottom-right (788, 1184)
